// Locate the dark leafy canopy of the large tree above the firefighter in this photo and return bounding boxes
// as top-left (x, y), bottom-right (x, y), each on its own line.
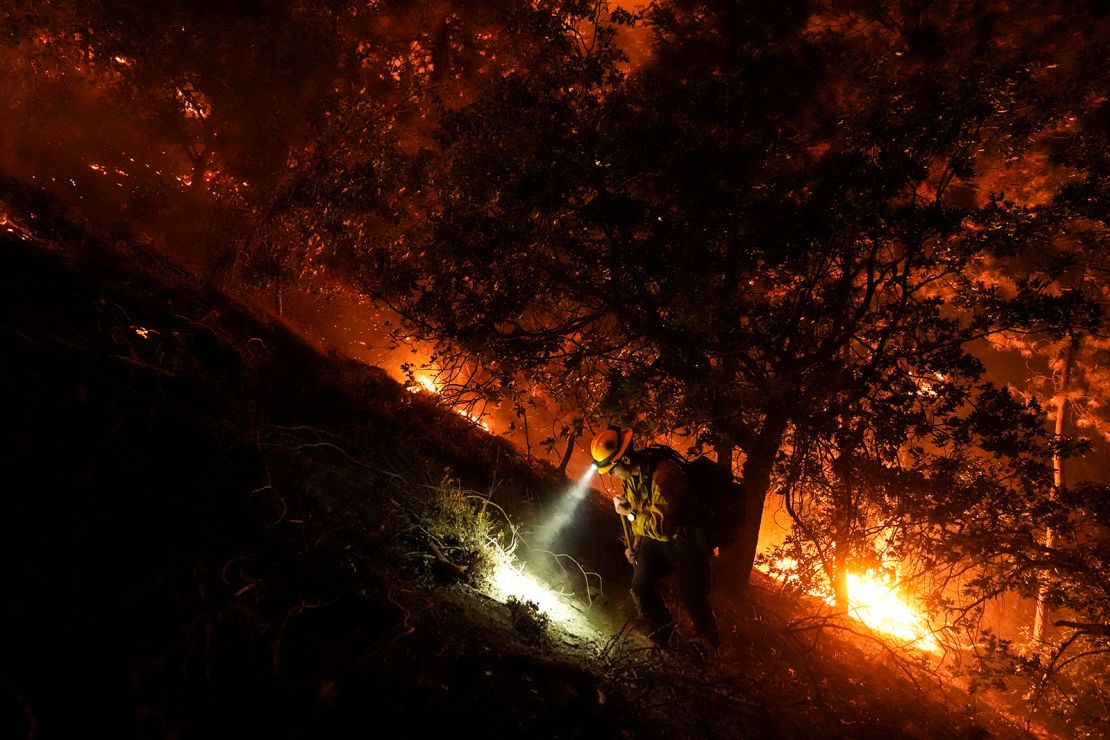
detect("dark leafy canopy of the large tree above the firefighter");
top-left (270, 2), bottom-right (1106, 590)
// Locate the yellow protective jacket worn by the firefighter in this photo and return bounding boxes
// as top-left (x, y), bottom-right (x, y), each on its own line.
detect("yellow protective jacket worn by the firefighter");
top-left (622, 456), bottom-right (695, 541)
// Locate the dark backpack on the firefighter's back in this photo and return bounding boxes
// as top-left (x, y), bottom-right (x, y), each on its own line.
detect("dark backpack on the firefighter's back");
top-left (645, 445), bottom-right (746, 547)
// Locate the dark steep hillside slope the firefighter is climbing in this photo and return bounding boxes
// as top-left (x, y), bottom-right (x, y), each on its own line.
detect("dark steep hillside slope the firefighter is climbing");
top-left (0, 204), bottom-right (1028, 738)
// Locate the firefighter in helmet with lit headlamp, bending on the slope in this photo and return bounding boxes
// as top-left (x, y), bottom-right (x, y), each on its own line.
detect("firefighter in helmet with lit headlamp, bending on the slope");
top-left (591, 425), bottom-right (720, 649)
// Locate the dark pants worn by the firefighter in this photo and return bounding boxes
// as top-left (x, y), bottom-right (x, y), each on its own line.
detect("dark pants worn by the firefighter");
top-left (632, 537), bottom-right (720, 645)
